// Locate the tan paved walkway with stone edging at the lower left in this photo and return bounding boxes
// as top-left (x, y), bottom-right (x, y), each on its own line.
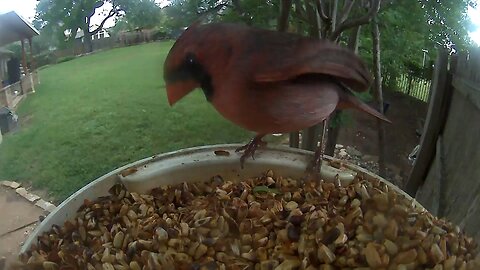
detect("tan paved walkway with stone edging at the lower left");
top-left (0, 181), bottom-right (54, 270)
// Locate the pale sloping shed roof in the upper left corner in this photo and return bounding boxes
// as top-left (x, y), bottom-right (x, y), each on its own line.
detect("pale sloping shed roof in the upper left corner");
top-left (0, 11), bottom-right (40, 46)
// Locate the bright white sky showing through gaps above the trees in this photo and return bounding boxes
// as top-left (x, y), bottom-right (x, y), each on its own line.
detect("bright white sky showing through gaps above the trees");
top-left (0, 0), bottom-right (480, 46)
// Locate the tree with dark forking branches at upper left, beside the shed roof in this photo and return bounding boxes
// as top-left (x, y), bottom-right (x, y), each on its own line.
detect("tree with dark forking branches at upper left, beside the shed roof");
top-left (35, 0), bottom-right (127, 52)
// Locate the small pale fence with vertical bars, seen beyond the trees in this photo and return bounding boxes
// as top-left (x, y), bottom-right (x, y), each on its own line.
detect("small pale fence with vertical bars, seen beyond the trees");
top-left (396, 75), bottom-right (431, 102)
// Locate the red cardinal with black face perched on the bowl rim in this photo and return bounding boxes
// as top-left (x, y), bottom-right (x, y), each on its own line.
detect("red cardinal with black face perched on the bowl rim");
top-left (164, 23), bottom-right (388, 171)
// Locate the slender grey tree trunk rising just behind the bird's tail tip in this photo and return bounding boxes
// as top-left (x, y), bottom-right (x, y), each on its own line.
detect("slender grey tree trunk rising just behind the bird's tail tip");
top-left (372, 16), bottom-right (386, 177)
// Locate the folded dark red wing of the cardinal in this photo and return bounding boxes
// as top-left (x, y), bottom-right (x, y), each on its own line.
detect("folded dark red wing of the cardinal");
top-left (254, 40), bottom-right (372, 91)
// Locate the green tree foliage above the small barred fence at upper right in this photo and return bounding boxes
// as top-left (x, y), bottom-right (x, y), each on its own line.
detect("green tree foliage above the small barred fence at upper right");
top-left (359, 0), bottom-right (472, 88)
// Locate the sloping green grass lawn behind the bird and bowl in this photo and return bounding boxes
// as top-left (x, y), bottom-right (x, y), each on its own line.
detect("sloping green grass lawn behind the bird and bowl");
top-left (0, 42), bottom-right (262, 201)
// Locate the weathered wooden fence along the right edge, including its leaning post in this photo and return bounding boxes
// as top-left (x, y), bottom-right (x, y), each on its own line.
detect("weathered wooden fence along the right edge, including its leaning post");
top-left (406, 49), bottom-right (480, 242)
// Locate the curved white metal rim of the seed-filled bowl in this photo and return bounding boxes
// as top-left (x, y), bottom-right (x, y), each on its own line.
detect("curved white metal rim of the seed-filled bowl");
top-left (20, 144), bottom-right (423, 253)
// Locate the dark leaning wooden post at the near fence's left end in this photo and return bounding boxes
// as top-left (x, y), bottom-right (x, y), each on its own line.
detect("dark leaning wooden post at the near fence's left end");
top-left (405, 50), bottom-right (452, 197)
